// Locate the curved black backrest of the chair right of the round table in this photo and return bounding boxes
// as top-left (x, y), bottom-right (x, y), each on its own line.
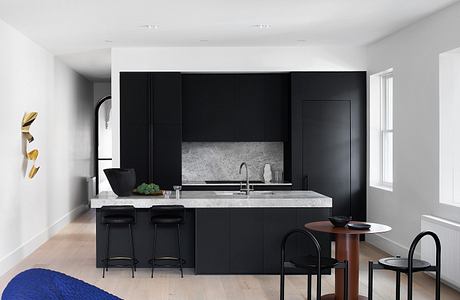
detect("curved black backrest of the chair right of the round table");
top-left (407, 231), bottom-right (441, 299)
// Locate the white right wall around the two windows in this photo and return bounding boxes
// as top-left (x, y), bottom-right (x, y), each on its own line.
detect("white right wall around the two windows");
top-left (368, 4), bottom-right (460, 254)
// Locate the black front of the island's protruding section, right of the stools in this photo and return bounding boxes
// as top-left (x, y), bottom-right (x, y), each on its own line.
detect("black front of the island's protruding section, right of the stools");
top-left (195, 208), bottom-right (331, 274)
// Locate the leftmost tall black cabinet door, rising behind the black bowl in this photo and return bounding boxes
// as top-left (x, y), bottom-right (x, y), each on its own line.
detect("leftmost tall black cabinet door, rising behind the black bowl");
top-left (120, 72), bottom-right (153, 184)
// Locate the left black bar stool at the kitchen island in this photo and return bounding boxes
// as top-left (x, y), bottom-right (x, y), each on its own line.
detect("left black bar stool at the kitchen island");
top-left (101, 205), bottom-right (138, 278)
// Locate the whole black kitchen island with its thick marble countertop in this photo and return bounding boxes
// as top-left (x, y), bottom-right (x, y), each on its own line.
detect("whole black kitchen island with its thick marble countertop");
top-left (91, 191), bottom-right (332, 274)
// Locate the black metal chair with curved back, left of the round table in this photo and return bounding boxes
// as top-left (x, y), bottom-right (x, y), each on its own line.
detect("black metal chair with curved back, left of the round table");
top-left (280, 229), bottom-right (348, 300)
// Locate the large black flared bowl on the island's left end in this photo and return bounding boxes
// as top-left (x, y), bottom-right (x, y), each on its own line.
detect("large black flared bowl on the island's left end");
top-left (104, 168), bottom-right (136, 197)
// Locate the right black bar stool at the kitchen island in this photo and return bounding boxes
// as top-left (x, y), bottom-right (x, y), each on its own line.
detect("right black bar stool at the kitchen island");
top-left (149, 205), bottom-right (185, 278)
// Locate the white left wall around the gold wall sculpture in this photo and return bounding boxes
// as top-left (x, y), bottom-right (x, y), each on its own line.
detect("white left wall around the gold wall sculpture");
top-left (0, 20), bottom-right (93, 275)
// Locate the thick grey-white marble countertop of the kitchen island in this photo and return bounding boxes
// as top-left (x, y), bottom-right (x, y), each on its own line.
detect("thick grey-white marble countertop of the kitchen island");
top-left (91, 191), bottom-right (332, 208)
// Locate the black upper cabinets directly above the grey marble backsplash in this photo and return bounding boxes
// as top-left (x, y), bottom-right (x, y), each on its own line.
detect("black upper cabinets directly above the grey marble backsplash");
top-left (182, 73), bottom-right (290, 142)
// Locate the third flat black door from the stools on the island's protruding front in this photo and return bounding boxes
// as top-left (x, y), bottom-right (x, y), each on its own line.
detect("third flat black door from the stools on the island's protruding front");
top-left (264, 208), bottom-right (298, 274)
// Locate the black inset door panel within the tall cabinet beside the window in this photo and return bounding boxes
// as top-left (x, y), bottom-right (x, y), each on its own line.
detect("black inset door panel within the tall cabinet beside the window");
top-left (302, 100), bottom-right (351, 216)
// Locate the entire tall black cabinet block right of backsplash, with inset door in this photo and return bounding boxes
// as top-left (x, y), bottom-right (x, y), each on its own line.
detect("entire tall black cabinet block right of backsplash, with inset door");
top-left (291, 72), bottom-right (366, 221)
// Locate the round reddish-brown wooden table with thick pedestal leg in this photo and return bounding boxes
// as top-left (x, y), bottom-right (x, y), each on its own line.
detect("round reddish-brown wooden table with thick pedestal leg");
top-left (304, 221), bottom-right (391, 300)
